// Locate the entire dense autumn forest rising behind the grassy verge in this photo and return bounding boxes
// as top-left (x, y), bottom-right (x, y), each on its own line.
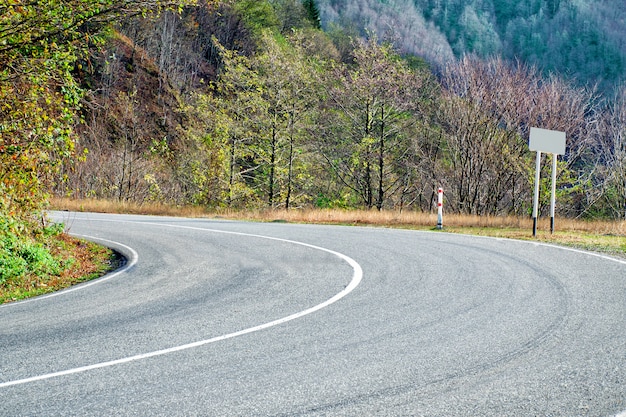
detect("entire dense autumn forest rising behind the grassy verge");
top-left (0, 0), bottom-right (626, 230)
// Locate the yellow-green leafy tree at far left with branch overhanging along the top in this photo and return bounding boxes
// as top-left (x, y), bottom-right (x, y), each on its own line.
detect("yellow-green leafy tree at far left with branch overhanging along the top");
top-left (0, 0), bottom-right (190, 223)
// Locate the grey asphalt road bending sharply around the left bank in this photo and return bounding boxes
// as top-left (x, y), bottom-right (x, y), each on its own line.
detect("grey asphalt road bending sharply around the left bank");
top-left (0, 213), bottom-right (626, 416)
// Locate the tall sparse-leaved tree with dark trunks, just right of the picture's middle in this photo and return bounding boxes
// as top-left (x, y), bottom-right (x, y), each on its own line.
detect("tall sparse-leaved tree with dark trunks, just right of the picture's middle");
top-left (320, 37), bottom-right (424, 210)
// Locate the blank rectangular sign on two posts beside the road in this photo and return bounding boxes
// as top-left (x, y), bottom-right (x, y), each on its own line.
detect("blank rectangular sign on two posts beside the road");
top-left (528, 127), bottom-right (565, 236)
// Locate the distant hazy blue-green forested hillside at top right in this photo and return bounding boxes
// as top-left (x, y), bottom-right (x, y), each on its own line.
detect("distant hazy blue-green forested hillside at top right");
top-left (319, 0), bottom-right (626, 92)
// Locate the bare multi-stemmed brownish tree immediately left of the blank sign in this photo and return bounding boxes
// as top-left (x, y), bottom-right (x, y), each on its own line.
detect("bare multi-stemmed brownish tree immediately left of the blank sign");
top-left (440, 58), bottom-right (532, 214)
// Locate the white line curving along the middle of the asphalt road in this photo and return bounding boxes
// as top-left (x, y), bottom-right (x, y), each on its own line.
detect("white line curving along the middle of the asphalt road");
top-left (0, 222), bottom-right (363, 388)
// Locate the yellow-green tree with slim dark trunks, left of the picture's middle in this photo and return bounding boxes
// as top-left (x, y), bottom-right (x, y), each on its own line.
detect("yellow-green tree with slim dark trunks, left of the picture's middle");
top-left (205, 31), bottom-right (316, 209)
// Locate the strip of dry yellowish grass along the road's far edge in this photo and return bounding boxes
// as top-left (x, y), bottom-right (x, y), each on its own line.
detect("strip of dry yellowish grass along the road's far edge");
top-left (53, 199), bottom-right (626, 258)
